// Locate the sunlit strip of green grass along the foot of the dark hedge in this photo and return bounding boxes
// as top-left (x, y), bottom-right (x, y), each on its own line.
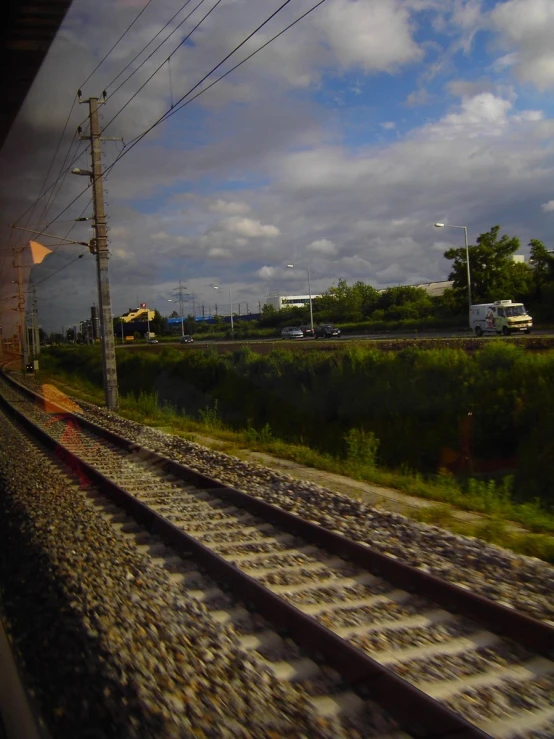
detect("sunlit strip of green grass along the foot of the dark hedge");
top-left (35, 373), bottom-right (554, 562)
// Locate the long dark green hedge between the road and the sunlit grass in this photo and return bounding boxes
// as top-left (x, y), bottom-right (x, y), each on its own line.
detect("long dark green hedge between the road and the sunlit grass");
top-left (42, 339), bottom-right (554, 504)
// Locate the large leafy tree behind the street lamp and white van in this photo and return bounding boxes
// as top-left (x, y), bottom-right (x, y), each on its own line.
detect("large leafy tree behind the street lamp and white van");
top-left (444, 226), bottom-right (531, 303)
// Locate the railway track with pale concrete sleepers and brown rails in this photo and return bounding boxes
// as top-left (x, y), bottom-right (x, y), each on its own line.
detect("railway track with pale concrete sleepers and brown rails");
top-left (2, 372), bottom-right (554, 737)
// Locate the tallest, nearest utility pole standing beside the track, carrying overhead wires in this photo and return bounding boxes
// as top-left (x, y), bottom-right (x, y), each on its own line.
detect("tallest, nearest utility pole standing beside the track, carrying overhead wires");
top-left (74, 91), bottom-right (119, 412)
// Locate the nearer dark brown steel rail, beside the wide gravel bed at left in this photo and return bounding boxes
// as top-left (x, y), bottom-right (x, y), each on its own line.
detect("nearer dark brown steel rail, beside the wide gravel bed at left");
top-left (0, 378), bottom-right (489, 739)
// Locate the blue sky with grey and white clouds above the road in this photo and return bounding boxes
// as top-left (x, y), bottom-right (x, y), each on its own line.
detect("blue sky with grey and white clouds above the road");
top-left (0, 0), bottom-right (554, 331)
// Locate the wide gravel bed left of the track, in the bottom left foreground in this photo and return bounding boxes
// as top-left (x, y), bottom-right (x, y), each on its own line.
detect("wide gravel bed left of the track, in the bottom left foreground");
top-left (0, 416), bottom-right (354, 739)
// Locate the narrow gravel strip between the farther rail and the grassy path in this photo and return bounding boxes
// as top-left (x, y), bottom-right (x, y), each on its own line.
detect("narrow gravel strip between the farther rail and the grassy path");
top-left (68, 396), bottom-right (554, 623)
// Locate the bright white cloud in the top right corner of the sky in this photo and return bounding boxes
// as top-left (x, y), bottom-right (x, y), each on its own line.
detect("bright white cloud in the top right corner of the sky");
top-left (490, 0), bottom-right (554, 90)
